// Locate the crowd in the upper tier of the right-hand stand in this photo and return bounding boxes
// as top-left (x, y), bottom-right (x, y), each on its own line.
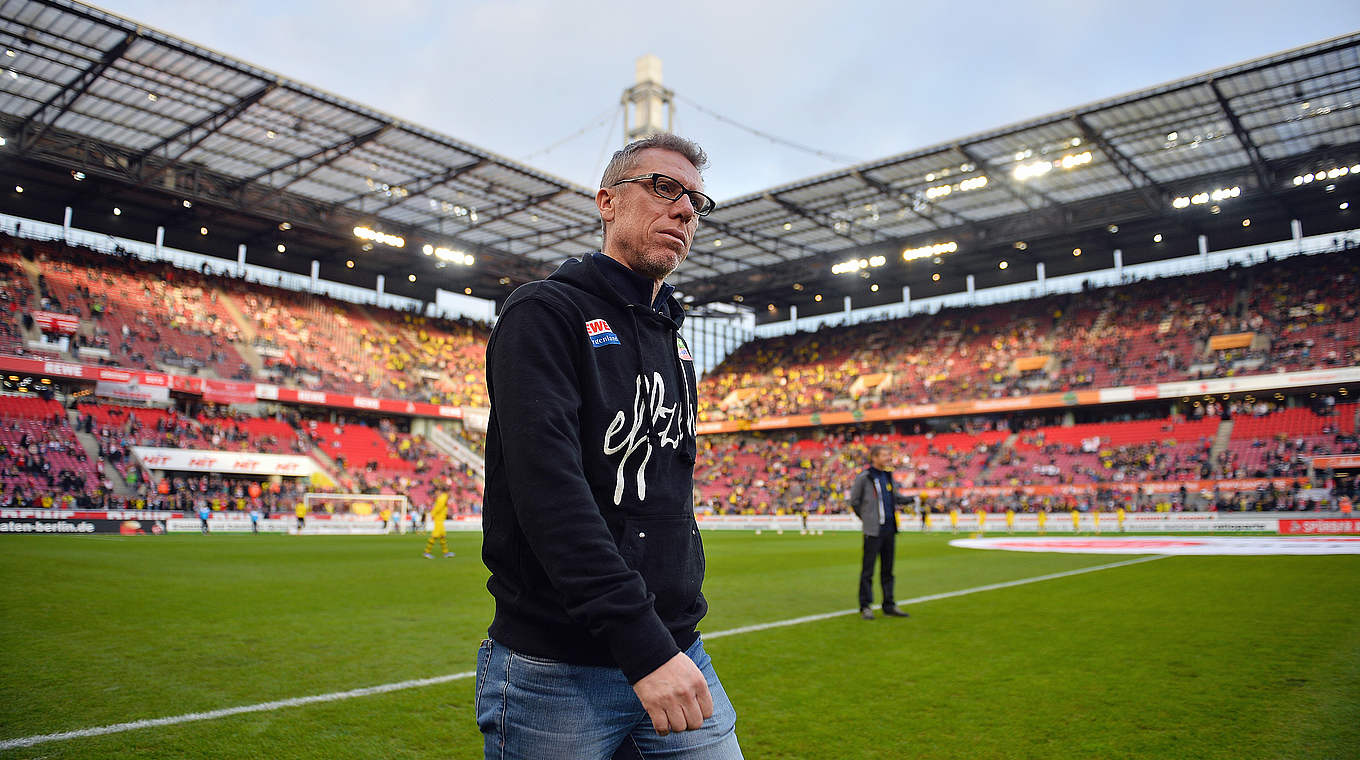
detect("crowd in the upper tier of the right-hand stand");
top-left (699, 253), bottom-right (1360, 420)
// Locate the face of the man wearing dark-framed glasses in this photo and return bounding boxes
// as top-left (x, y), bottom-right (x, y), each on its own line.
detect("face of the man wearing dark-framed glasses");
top-left (596, 148), bottom-right (703, 280)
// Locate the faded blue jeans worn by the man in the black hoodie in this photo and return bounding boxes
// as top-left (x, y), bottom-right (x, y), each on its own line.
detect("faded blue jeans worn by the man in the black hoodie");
top-left (476, 639), bottom-right (741, 760)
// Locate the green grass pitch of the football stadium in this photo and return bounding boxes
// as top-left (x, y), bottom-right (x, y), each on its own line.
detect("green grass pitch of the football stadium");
top-left (0, 533), bottom-right (1360, 760)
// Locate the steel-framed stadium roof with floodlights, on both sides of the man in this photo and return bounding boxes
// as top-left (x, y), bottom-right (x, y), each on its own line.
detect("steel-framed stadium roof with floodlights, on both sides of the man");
top-left (0, 0), bottom-right (1360, 313)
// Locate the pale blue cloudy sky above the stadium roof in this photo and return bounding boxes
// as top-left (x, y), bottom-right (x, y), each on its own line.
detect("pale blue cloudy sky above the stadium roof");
top-left (95, 0), bottom-right (1360, 203)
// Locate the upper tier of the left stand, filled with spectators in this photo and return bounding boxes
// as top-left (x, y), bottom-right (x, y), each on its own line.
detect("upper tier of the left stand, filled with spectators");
top-left (11, 239), bottom-right (500, 407)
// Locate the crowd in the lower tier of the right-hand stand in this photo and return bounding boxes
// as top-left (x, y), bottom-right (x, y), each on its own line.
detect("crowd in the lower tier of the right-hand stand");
top-left (695, 401), bottom-right (1360, 514)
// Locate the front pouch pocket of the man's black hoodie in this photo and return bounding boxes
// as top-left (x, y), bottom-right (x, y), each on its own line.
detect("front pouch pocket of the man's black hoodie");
top-left (620, 515), bottom-right (704, 623)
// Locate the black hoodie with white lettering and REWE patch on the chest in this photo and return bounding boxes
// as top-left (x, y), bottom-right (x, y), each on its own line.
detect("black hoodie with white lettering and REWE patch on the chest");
top-left (481, 256), bottom-right (709, 683)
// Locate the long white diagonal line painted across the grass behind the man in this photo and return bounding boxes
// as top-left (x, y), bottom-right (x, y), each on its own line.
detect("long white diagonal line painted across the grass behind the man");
top-left (0, 555), bottom-right (1167, 750)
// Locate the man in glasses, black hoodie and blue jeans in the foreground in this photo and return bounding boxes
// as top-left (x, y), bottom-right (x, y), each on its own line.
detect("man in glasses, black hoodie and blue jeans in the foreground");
top-left (476, 135), bottom-right (741, 760)
